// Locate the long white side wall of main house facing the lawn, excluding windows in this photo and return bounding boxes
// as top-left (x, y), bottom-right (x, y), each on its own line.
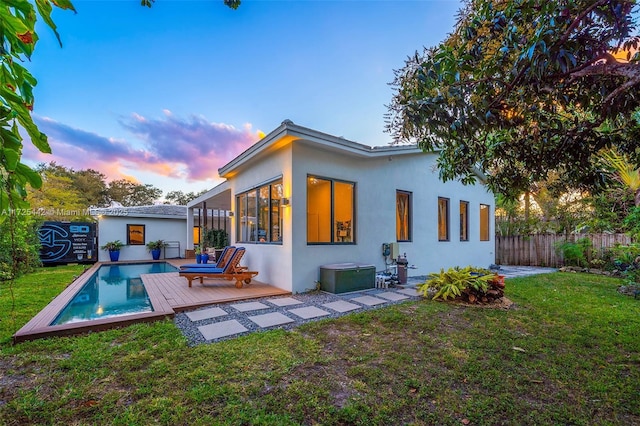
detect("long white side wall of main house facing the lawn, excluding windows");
top-left (287, 143), bottom-right (495, 293)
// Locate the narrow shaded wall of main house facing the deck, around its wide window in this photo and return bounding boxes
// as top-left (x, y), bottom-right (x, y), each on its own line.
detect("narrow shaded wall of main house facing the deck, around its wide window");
top-left (228, 145), bottom-right (293, 290)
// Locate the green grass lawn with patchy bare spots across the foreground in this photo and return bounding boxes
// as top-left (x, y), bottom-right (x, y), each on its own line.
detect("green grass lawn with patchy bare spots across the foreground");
top-left (0, 267), bottom-right (640, 425)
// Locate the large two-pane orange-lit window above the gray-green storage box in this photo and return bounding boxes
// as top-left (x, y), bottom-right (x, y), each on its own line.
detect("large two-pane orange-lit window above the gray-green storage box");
top-left (307, 176), bottom-right (355, 244)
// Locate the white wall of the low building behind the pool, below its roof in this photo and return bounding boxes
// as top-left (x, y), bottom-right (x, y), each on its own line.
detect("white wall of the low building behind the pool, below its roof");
top-left (98, 216), bottom-right (187, 262)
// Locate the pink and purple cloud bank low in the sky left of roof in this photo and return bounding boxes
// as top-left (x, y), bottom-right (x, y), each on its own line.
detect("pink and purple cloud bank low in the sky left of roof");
top-left (23, 111), bottom-right (262, 182)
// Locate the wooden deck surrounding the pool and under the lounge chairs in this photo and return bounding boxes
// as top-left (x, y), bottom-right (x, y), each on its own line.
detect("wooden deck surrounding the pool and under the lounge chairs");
top-left (13, 259), bottom-right (291, 343)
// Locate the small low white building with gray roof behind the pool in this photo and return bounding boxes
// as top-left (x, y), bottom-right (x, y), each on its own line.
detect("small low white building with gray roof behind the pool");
top-left (91, 204), bottom-right (187, 262)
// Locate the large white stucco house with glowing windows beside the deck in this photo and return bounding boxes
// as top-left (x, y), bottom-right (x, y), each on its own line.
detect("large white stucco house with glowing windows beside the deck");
top-left (186, 120), bottom-right (495, 293)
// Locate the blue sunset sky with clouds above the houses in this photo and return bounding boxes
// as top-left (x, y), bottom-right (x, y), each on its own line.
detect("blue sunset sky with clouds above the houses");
top-left (24, 0), bottom-right (461, 196)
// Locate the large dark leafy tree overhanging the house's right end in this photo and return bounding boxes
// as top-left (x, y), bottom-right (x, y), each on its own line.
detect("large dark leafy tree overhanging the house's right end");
top-left (387, 0), bottom-right (640, 198)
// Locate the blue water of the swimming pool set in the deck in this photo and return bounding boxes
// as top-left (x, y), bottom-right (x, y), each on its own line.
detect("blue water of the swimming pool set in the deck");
top-left (51, 262), bottom-right (178, 325)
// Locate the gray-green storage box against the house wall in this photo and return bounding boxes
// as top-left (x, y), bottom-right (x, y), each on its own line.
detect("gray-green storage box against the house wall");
top-left (320, 262), bottom-right (376, 293)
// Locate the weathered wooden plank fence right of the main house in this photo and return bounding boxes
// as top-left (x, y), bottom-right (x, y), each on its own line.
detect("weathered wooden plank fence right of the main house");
top-left (496, 234), bottom-right (631, 268)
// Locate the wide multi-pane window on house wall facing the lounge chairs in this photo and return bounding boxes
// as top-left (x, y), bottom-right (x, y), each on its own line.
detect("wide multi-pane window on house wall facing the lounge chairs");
top-left (236, 179), bottom-right (282, 243)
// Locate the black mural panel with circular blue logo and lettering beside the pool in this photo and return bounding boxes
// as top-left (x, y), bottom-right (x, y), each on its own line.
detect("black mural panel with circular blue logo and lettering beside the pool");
top-left (38, 222), bottom-right (98, 265)
